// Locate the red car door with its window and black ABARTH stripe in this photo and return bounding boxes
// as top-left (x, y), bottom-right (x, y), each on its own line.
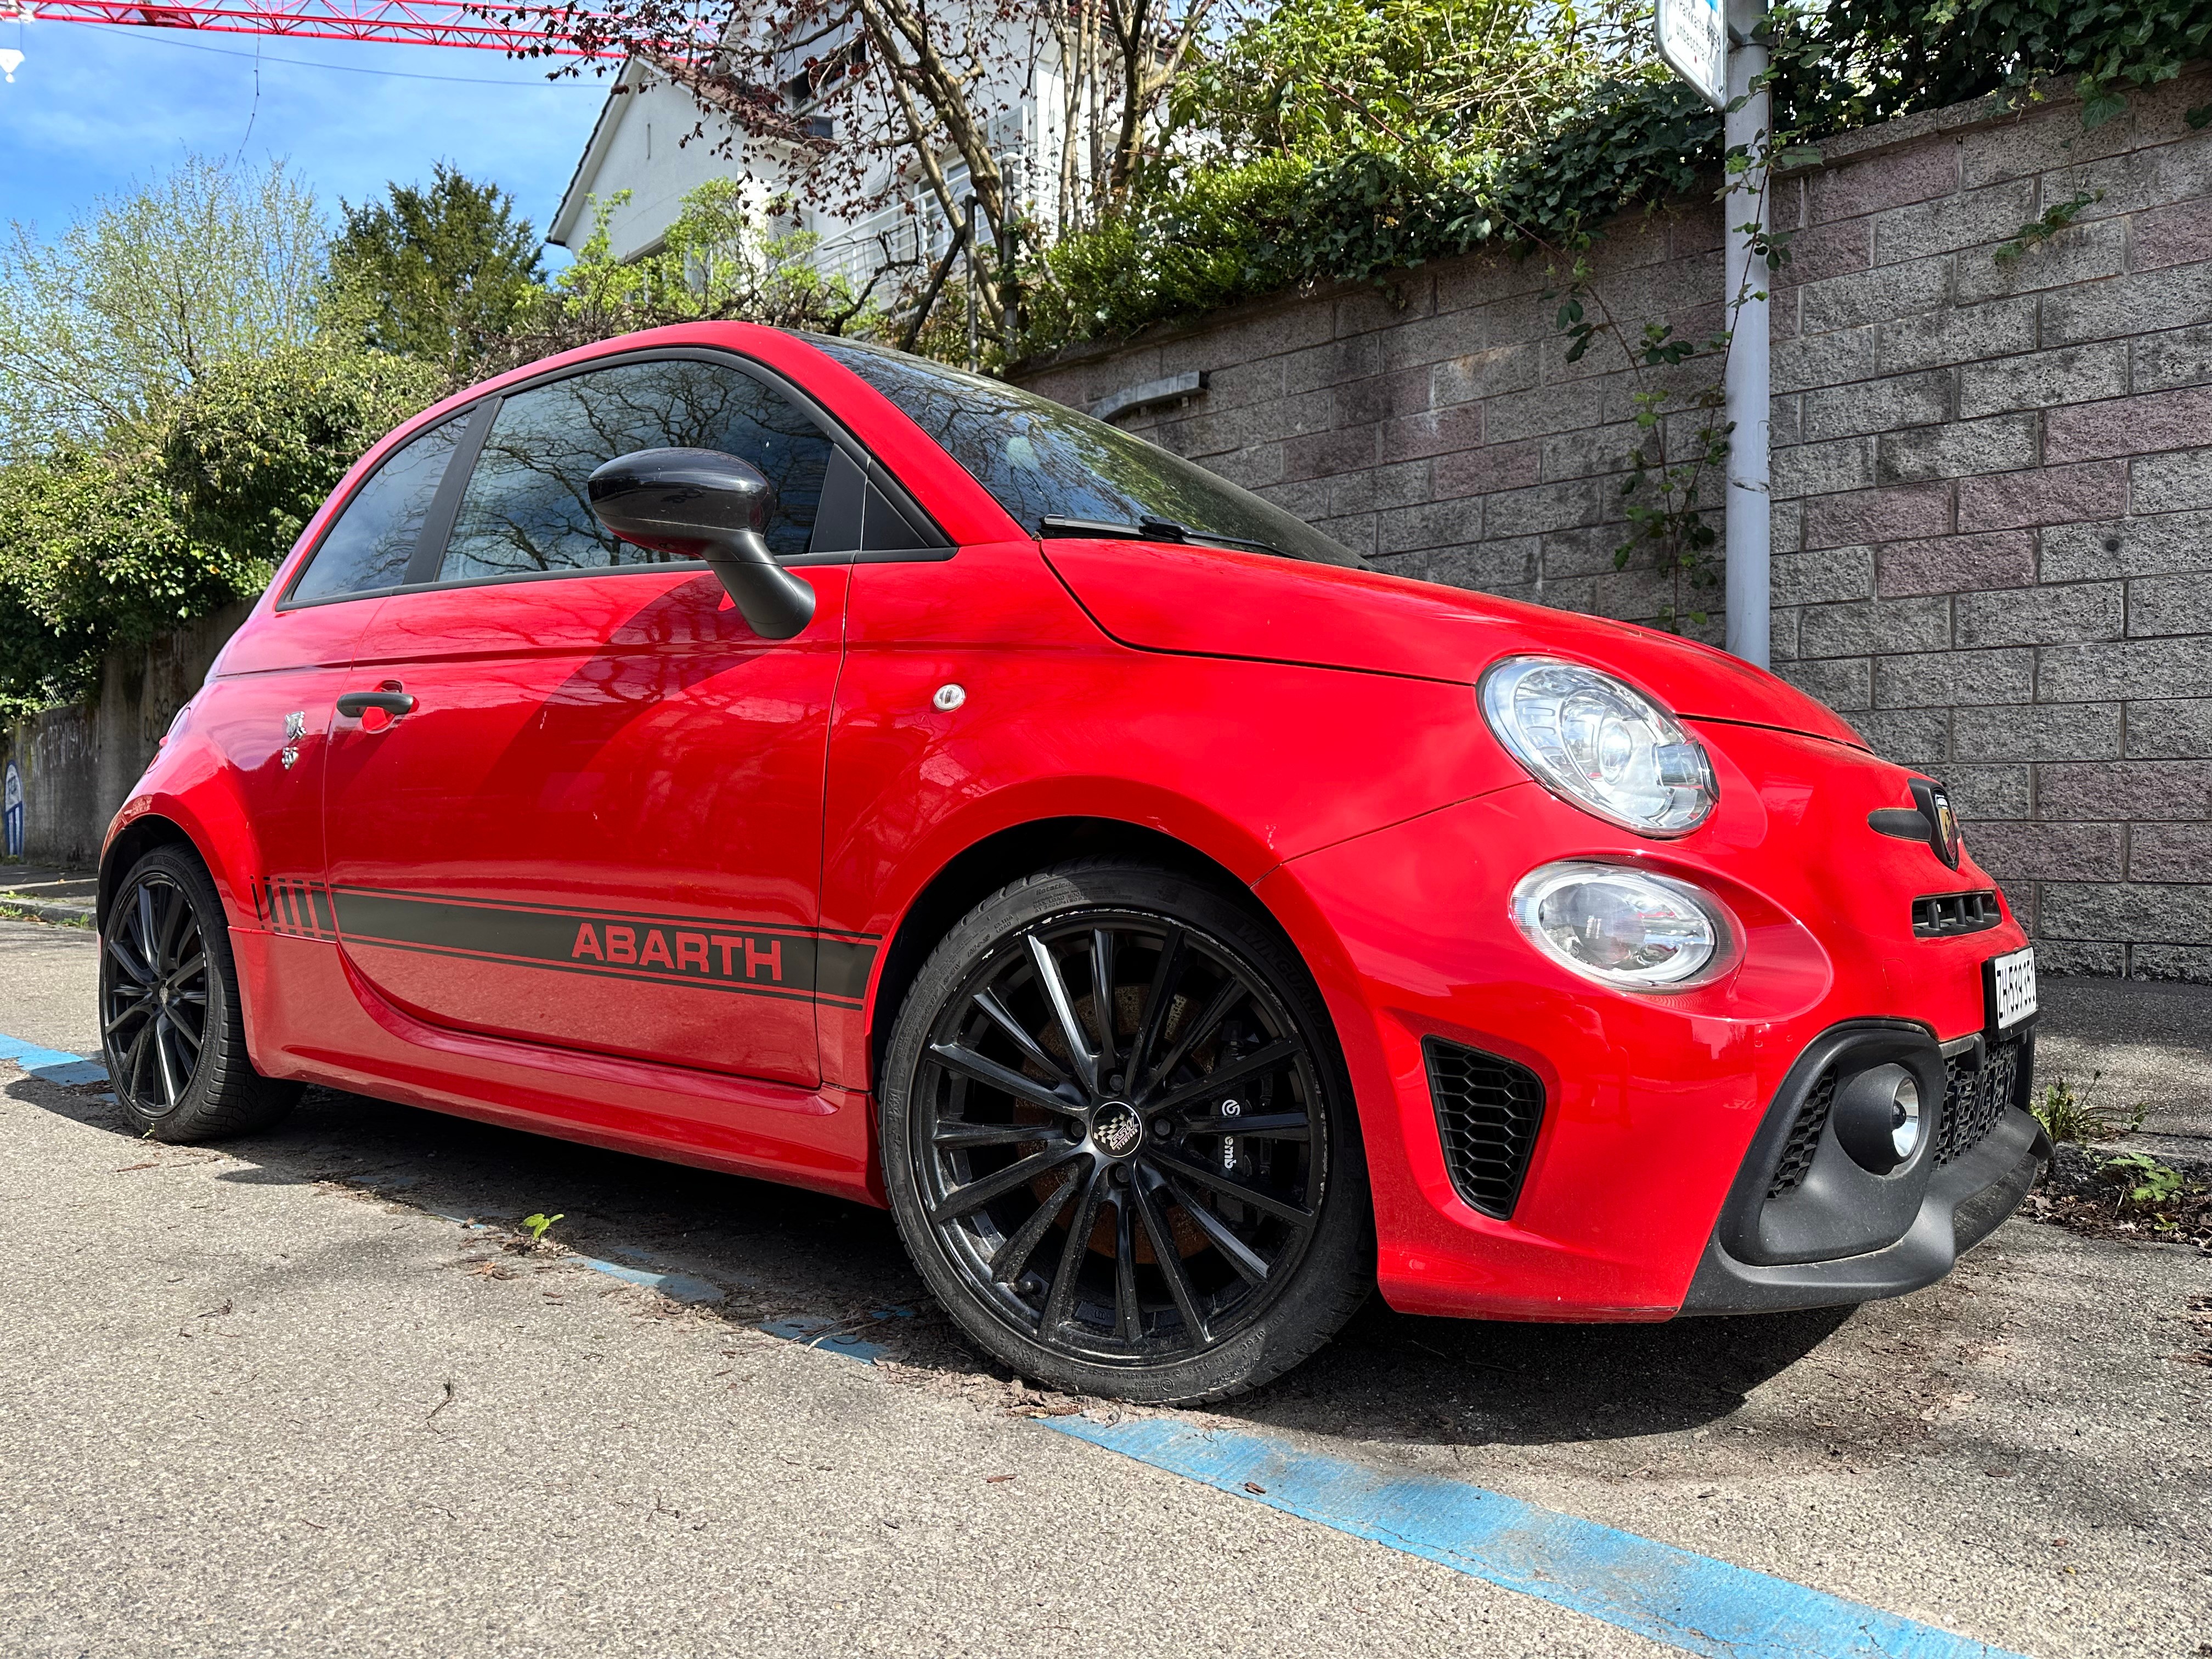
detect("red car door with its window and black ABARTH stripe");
top-left (325, 352), bottom-right (856, 1084)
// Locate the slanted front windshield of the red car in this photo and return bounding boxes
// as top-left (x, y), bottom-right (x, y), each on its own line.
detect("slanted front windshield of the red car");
top-left (808, 336), bottom-right (1363, 564)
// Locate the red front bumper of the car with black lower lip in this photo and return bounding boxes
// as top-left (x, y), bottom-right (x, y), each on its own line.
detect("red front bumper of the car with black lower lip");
top-left (1256, 730), bottom-right (2042, 1321)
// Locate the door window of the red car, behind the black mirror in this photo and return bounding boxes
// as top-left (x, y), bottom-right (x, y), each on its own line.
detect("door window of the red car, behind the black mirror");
top-left (438, 358), bottom-right (834, 582)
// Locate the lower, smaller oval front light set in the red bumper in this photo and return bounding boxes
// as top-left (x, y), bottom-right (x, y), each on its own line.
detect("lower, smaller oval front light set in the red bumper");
top-left (1513, 862), bottom-right (1728, 991)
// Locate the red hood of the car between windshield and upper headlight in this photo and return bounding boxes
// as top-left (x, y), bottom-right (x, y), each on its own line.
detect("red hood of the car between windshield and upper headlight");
top-left (1042, 540), bottom-right (1867, 748)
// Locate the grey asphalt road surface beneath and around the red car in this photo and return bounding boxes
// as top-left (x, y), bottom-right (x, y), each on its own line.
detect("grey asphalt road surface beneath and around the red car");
top-left (0, 922), bottom-right (2212, 1659)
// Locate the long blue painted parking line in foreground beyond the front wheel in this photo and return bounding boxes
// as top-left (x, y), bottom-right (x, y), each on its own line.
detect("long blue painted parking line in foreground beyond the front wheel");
top-left (1042, 1415), bottom-right (2019, 1659)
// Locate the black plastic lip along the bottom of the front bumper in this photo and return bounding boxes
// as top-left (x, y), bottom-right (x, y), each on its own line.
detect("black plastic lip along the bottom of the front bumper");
top-left (1681, 1106), bottom-right (2051, 1314)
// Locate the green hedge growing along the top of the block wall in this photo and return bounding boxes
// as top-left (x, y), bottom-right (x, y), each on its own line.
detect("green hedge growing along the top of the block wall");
top-left (1024, 0), bottom-right (2212, 356)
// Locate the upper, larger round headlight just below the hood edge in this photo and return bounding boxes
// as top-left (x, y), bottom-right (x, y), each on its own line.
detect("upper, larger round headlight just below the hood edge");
top-left (1480, 657), bottom-right (1721, 836)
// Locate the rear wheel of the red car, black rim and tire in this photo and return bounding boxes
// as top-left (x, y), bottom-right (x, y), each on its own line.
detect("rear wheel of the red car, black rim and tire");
top-left (99, 845), bottom-right (301, 1142)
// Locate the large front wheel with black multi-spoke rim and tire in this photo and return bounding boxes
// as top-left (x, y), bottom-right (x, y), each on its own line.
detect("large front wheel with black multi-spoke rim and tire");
top-left (881, 860), bottom-right (1374, 1404)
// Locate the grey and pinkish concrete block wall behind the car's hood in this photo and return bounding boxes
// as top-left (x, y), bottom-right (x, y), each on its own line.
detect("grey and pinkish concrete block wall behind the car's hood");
top-left (1020, 71), bottom-right (2212, 980)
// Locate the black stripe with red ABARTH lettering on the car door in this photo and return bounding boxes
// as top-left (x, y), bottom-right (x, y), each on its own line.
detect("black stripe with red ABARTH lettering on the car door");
top-left (332, 887), bottom-right (816, 995)
